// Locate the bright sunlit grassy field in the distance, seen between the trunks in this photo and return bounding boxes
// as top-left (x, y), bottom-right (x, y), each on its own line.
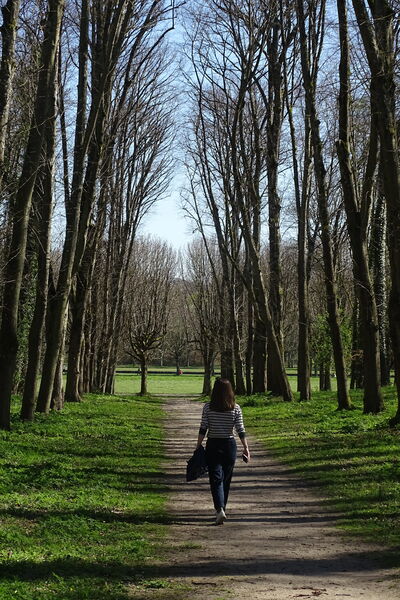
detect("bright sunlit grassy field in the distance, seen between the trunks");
top-left (115, 367), bottom-right (336, 396)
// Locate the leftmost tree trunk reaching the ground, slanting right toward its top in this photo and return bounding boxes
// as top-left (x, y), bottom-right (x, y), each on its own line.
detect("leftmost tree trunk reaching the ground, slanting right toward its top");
top-left (0, 0), bottom-right (64, 429)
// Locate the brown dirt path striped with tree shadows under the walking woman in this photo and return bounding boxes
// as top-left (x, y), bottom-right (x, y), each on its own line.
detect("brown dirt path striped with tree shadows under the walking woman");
top-left (133, 399), bottom-right (400, 600)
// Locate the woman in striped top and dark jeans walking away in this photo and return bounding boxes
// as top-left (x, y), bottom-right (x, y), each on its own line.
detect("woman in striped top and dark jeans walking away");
top-left (197, 379), bottom-right (250, 525)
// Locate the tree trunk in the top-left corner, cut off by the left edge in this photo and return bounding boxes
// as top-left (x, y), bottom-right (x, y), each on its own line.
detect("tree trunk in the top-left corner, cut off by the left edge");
top-left (0, 0), bottom-right (20, 190)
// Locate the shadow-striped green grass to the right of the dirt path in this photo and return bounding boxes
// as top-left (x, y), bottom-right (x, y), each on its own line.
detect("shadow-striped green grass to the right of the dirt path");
top-left (238, 387), bottom-right (400, 548)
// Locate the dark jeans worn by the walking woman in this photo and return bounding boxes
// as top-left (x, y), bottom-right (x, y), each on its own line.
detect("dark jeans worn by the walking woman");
top-left (206, 438), bottom-right (237, 510)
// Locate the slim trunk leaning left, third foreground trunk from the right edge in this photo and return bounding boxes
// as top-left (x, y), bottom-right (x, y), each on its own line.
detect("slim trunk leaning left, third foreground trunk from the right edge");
top-left (297, 0), bottom-right (351, 409)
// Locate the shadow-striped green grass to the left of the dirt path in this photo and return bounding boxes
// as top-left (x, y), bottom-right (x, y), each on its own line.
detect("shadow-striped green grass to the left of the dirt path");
top-left (0, 395), bottom-right (167, 600)
